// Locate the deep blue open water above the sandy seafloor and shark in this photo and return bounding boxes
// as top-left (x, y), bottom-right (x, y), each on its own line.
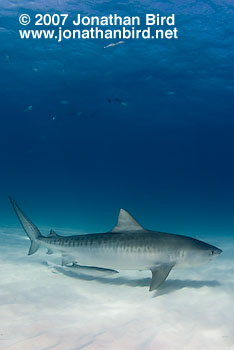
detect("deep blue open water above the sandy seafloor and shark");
top-left (0, 0), bottom-right (234, 237)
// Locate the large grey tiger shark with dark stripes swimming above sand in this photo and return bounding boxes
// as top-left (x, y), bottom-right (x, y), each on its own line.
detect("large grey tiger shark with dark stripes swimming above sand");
top-left (10, 198), bottom-right (222, 291)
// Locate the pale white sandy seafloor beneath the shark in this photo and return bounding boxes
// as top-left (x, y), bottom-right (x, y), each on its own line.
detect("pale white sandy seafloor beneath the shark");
top-left (0, 227), bottom-right (234, 350)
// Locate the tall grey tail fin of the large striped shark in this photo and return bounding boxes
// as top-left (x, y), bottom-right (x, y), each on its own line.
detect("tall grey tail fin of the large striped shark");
top-left (9, 197), bottom-right (42, 255)
